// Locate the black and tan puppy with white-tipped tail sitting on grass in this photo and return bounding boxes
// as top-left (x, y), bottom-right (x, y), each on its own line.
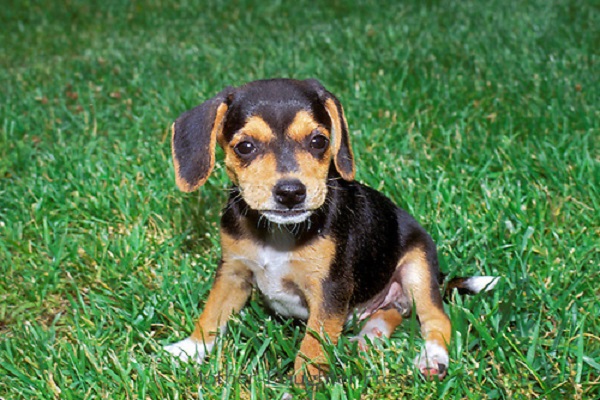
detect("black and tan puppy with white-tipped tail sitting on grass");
top-left (166, 79), bottom-right (496, 378)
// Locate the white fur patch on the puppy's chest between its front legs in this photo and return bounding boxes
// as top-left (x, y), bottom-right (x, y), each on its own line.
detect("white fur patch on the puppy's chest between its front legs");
top-left (237, 246), bottom-right (308, 319)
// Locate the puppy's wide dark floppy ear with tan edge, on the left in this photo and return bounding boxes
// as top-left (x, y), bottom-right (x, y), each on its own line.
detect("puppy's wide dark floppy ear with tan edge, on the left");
top-left (171, 88), bottom-right (232, 192)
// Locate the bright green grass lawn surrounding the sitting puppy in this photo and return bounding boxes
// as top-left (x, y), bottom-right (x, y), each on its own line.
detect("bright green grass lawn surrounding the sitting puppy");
top-left (0, 0), bottom-right (600, 399)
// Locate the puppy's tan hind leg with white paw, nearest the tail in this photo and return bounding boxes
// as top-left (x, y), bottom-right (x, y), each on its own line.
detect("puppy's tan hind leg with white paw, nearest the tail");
top-left (400, 249), bottom-right (452, 379)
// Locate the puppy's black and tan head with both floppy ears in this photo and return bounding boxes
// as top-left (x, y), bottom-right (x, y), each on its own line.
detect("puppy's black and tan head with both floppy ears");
top-left (172, 79), bottom-right (354, 224)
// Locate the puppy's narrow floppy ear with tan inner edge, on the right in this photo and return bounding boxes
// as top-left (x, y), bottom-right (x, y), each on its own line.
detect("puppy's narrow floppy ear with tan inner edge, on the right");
top-left (305, 79), bottom-right (355, 181)
